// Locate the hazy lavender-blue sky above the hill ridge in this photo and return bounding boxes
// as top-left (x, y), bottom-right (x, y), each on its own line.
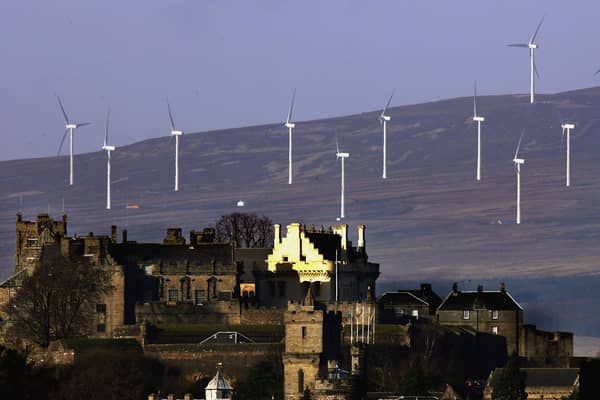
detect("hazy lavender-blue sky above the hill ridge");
top-left (0, 0), bottom-right (600, 160)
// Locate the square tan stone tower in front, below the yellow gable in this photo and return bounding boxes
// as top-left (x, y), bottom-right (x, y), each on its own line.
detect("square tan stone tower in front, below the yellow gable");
top-left (283, 289), bottom-right (323, 400)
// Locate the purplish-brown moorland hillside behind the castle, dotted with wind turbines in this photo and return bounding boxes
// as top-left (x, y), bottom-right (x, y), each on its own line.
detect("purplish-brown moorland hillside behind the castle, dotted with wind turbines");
top-left (0, 88), bottom-right (600, 279)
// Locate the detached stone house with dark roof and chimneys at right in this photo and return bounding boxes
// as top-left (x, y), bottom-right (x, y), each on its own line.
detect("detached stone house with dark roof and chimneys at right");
top-left (437, 284), bottom-right (523, 354)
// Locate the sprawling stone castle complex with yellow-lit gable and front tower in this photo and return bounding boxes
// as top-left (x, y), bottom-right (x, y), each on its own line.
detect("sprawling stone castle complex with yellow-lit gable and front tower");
top-left (0, 213), bottom-right (573, 399)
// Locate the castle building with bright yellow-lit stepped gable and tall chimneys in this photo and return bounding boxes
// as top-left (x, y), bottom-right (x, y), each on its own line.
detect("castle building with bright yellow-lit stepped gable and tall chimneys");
top-left (254, 223), bottom-right (379, 307)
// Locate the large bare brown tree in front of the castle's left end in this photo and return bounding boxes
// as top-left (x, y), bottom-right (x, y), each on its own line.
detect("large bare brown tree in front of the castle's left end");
top-left (5, 255), bottom-right (112, 347)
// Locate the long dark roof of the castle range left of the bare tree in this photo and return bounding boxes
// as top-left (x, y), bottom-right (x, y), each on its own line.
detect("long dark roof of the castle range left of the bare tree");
top-left (110, 243), bottom-right (233, 265)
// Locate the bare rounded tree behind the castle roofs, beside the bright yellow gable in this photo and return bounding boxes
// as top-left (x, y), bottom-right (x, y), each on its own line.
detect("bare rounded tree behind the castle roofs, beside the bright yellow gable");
top-left (215, 212), bottom-right (273, 248)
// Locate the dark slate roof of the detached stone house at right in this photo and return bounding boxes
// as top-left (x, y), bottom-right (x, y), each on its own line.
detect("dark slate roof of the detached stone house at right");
top-left (438, 291), bottom-right (523, 311)
